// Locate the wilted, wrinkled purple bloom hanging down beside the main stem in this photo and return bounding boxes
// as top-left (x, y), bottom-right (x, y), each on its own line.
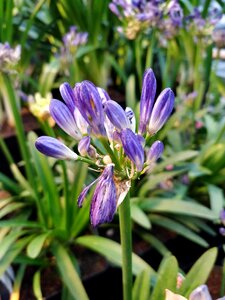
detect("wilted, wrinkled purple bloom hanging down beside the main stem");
top-left (90, 165), bottom-right (116, 227)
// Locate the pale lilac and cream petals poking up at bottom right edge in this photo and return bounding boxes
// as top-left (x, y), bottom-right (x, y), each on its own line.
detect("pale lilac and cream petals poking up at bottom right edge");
top-left (165, 284), bottom-right (225, 300)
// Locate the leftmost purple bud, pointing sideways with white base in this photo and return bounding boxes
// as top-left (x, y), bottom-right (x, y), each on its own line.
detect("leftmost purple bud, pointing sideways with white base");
top-left (35, 136), bottom-right (77, 160)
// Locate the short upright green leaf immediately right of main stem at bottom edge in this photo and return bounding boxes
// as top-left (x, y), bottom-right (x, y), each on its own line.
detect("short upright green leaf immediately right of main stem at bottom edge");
top-left (132, 269), bottom-right (151, 300)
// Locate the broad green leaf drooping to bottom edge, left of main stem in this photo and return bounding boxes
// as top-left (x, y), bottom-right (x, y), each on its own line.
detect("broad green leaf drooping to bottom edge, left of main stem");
top-left (52, 242), bottom-right (88, 300)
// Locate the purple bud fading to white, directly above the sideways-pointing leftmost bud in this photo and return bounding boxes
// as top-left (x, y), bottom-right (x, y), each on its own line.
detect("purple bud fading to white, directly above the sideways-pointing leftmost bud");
top-left (49, 99), bottom-right (82, 140)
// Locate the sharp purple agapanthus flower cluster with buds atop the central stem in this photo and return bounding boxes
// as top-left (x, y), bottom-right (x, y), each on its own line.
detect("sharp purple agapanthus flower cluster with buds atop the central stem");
top-left (36, 69), bottom-right (174, 226)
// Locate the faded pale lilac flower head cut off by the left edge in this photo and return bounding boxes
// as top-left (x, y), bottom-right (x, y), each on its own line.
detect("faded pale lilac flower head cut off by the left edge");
top-left (0, 43), bottom-right (21, 73)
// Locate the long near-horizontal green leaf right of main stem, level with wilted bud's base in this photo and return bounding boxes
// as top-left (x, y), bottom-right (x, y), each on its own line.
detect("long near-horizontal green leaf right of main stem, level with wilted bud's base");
top-left (137, 197), bottom-right (218, 220)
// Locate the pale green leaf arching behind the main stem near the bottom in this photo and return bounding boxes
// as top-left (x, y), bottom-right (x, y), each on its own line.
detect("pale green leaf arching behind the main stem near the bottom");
top-left (75, 236), bottom-right (156, 275)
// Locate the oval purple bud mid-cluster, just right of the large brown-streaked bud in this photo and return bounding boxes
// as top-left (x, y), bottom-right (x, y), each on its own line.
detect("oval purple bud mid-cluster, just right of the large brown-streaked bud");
top-left (104, 100), bottom-right (129, 130)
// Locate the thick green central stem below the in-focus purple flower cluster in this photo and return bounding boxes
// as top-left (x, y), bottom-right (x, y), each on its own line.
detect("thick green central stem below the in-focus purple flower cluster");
top-left (119, 193), bottom-right (132, 300)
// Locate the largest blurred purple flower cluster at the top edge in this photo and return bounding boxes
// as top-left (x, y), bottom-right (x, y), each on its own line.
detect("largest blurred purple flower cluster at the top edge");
top-left (109, 0), bottom-right (183, 39)
